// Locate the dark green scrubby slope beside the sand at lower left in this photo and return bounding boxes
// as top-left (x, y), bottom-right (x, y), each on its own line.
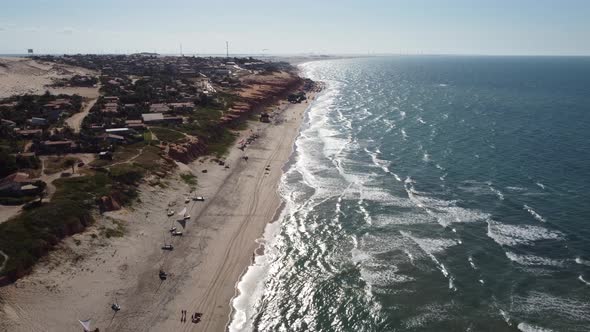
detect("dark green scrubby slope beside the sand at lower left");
top-left (0, 167), bottom-right (140, 279)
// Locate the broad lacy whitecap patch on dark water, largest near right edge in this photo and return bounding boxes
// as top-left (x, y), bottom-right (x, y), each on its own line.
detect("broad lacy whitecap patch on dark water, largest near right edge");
top-left (487, 220), bottom-right (563, 246)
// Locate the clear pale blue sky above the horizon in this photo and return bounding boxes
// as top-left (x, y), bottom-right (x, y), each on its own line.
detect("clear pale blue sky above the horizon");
top-left (0, 0), bottom-right (590, 55)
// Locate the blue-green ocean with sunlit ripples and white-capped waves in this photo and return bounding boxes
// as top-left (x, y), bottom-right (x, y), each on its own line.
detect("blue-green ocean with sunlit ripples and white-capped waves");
top-left (230, 56), bottom-right (590, 331)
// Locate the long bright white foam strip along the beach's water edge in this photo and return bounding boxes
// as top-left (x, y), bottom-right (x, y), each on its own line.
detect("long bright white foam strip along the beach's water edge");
top-left (228, 67), bottom-right (338, 332)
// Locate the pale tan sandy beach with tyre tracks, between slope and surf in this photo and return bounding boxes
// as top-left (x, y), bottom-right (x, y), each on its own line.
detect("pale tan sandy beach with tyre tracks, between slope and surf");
top-left (0, 87), bottom-right (316, 331)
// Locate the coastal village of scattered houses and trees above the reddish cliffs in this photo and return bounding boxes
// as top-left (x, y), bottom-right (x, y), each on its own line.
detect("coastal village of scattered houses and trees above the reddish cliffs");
top-left (0, 53), bottom-right (313, 210)
